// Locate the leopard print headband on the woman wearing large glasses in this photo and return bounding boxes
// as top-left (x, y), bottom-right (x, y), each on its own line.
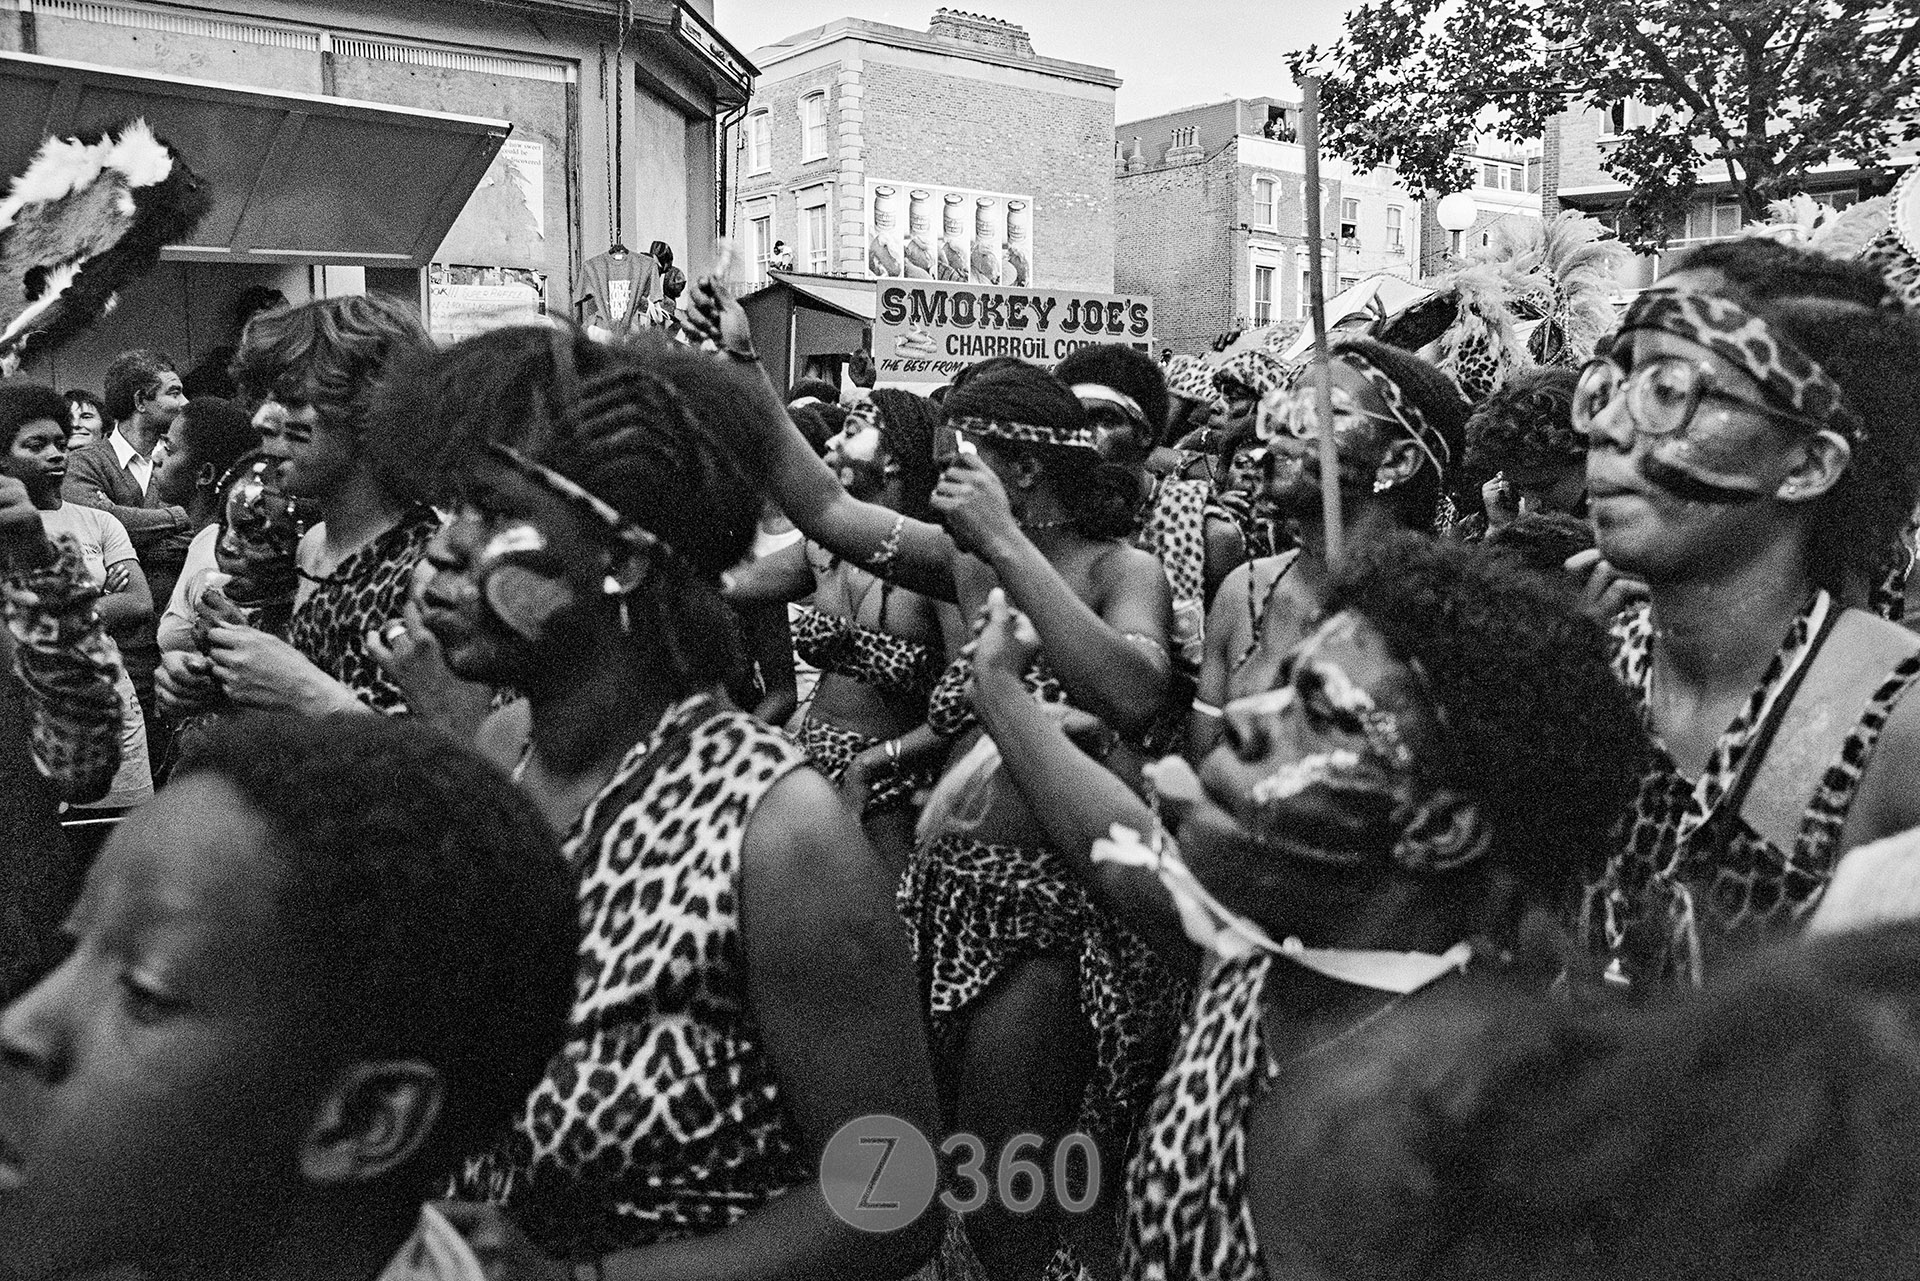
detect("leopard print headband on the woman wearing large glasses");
top-left (1617, 290), bottom-right (1866, 442)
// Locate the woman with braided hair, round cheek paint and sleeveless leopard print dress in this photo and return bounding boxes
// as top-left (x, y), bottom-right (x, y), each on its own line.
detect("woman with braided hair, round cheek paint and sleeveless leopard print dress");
top-left (362, 328), bottom-right (939, 1281)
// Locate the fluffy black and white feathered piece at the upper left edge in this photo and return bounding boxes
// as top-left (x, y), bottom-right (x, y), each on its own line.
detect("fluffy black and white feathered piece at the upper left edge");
top-left (0, 119), bottom-right (213, 361)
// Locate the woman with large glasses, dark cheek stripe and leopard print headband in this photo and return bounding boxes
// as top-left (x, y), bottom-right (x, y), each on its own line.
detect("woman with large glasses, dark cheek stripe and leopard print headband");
top-left (1574, 276), bottom-right (1920, 985)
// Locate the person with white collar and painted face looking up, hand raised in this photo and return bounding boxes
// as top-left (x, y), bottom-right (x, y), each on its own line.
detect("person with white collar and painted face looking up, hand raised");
top-left (973, 534), bottom-right (1644, 1281)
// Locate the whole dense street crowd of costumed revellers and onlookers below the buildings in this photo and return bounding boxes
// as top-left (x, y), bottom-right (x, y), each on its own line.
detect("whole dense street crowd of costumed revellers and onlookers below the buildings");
top-left (0, 238), bottom-right (1920, 1281)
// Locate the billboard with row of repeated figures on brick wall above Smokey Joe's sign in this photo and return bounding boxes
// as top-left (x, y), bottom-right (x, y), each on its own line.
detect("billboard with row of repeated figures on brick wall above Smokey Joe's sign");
top-left (866, 179), bottom-right (1033, 288)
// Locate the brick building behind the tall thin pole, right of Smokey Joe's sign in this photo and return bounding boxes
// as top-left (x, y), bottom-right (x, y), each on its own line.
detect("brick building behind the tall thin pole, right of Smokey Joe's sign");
top-left (1114, 98), bottom-right (1425, 351)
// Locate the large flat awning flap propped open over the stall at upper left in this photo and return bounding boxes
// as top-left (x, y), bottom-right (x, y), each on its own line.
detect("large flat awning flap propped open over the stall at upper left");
top-left (0, 52), bottom-right (513, 267)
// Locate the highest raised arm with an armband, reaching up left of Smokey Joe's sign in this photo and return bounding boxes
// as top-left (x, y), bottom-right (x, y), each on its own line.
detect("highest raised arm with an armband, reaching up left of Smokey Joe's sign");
top-left (687, 277), bottom-right (954, 601)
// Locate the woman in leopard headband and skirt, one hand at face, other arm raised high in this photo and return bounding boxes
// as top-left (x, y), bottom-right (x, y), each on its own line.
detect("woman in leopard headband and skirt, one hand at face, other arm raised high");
top-left (689, 280), bottom-right (1177, 1277)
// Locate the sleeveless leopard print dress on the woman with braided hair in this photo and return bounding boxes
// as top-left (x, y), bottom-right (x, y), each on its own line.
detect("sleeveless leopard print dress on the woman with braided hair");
top-left (455, 695), bottom-right (812, 1258)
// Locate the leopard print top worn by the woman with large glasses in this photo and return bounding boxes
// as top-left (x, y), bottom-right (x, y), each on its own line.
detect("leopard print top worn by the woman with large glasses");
top-left (1580, 593), bottom-right (1920, 985)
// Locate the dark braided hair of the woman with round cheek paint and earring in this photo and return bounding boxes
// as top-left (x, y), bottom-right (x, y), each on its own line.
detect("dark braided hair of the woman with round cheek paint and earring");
top-left (369, 326), bottom-right (760, 686)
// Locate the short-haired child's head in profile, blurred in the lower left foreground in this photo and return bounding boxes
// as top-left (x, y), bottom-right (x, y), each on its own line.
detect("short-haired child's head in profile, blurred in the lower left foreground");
top-left (0, 716), bottom-right (576, 1281)
